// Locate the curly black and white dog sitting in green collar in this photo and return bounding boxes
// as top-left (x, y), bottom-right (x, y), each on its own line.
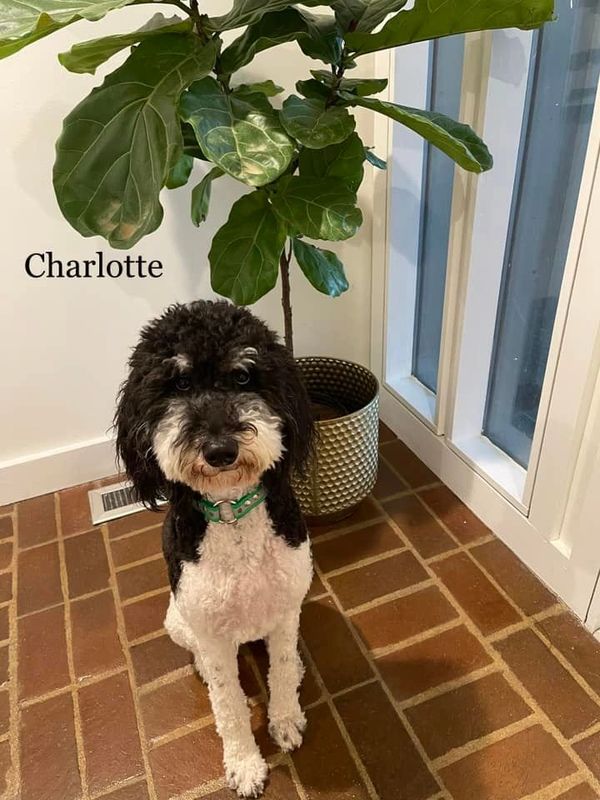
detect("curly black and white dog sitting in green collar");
top-left (115, 301), bottom-right (314, 797)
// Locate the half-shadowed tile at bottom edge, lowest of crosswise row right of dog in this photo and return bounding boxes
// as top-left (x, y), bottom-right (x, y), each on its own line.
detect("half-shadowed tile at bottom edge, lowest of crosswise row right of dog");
top-left (440, 725), bottom-right (575, 800)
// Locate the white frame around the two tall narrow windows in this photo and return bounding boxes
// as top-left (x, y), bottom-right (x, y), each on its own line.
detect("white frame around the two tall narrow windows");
top-left (371, 33), bottom-right (600, 627)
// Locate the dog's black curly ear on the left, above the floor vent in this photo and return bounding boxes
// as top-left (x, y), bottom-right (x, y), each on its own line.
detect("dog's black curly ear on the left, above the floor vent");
top-left (114, 368), bottom-right (168, 511)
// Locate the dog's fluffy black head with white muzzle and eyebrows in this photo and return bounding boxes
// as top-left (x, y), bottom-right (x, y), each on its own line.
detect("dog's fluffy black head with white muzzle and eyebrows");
top-left (115, 302), bottom-right (312, 505)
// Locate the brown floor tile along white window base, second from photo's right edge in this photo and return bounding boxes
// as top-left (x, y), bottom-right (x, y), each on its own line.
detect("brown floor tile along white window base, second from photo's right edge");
top-left (471, 539), bottom-right (557, 616)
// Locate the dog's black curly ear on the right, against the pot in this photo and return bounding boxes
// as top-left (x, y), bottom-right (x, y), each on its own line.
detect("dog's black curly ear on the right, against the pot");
top-left (268, 343), bottom-right (315, 474)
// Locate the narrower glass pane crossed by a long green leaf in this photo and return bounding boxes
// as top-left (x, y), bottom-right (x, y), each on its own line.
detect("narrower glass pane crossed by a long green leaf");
top-left (413, 36), bottom-right (464, 392)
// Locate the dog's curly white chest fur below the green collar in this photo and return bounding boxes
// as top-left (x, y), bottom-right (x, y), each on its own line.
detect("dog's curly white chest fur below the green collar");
top-left (174, 504), bottom-right (312, 643)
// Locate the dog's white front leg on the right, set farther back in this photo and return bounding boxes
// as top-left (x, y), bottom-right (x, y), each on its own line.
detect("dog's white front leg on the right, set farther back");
top-left (267, 611), bottom-right (306, 752)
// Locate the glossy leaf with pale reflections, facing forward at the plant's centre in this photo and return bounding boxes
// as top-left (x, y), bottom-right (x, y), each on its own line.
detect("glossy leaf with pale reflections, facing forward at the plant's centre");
top-left (180, 78), bottom-right (294, 186)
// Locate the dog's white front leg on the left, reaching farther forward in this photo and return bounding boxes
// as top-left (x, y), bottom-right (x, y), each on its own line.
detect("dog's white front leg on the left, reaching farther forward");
top-left (202, 639), bottom-right (268, 797)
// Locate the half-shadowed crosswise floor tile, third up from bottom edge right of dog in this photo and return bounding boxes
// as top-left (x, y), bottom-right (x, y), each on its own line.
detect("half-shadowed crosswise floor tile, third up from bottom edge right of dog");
top-left (377, 625), bottom-right (492, 701)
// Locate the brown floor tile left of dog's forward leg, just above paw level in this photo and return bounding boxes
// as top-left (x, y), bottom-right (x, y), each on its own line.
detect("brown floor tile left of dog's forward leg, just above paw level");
top-left (140, 674), bottom-right (212, 740)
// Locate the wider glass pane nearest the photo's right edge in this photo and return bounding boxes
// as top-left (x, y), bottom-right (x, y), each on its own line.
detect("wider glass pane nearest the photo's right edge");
top-left (483, 0), bottom-right (600, 467)
